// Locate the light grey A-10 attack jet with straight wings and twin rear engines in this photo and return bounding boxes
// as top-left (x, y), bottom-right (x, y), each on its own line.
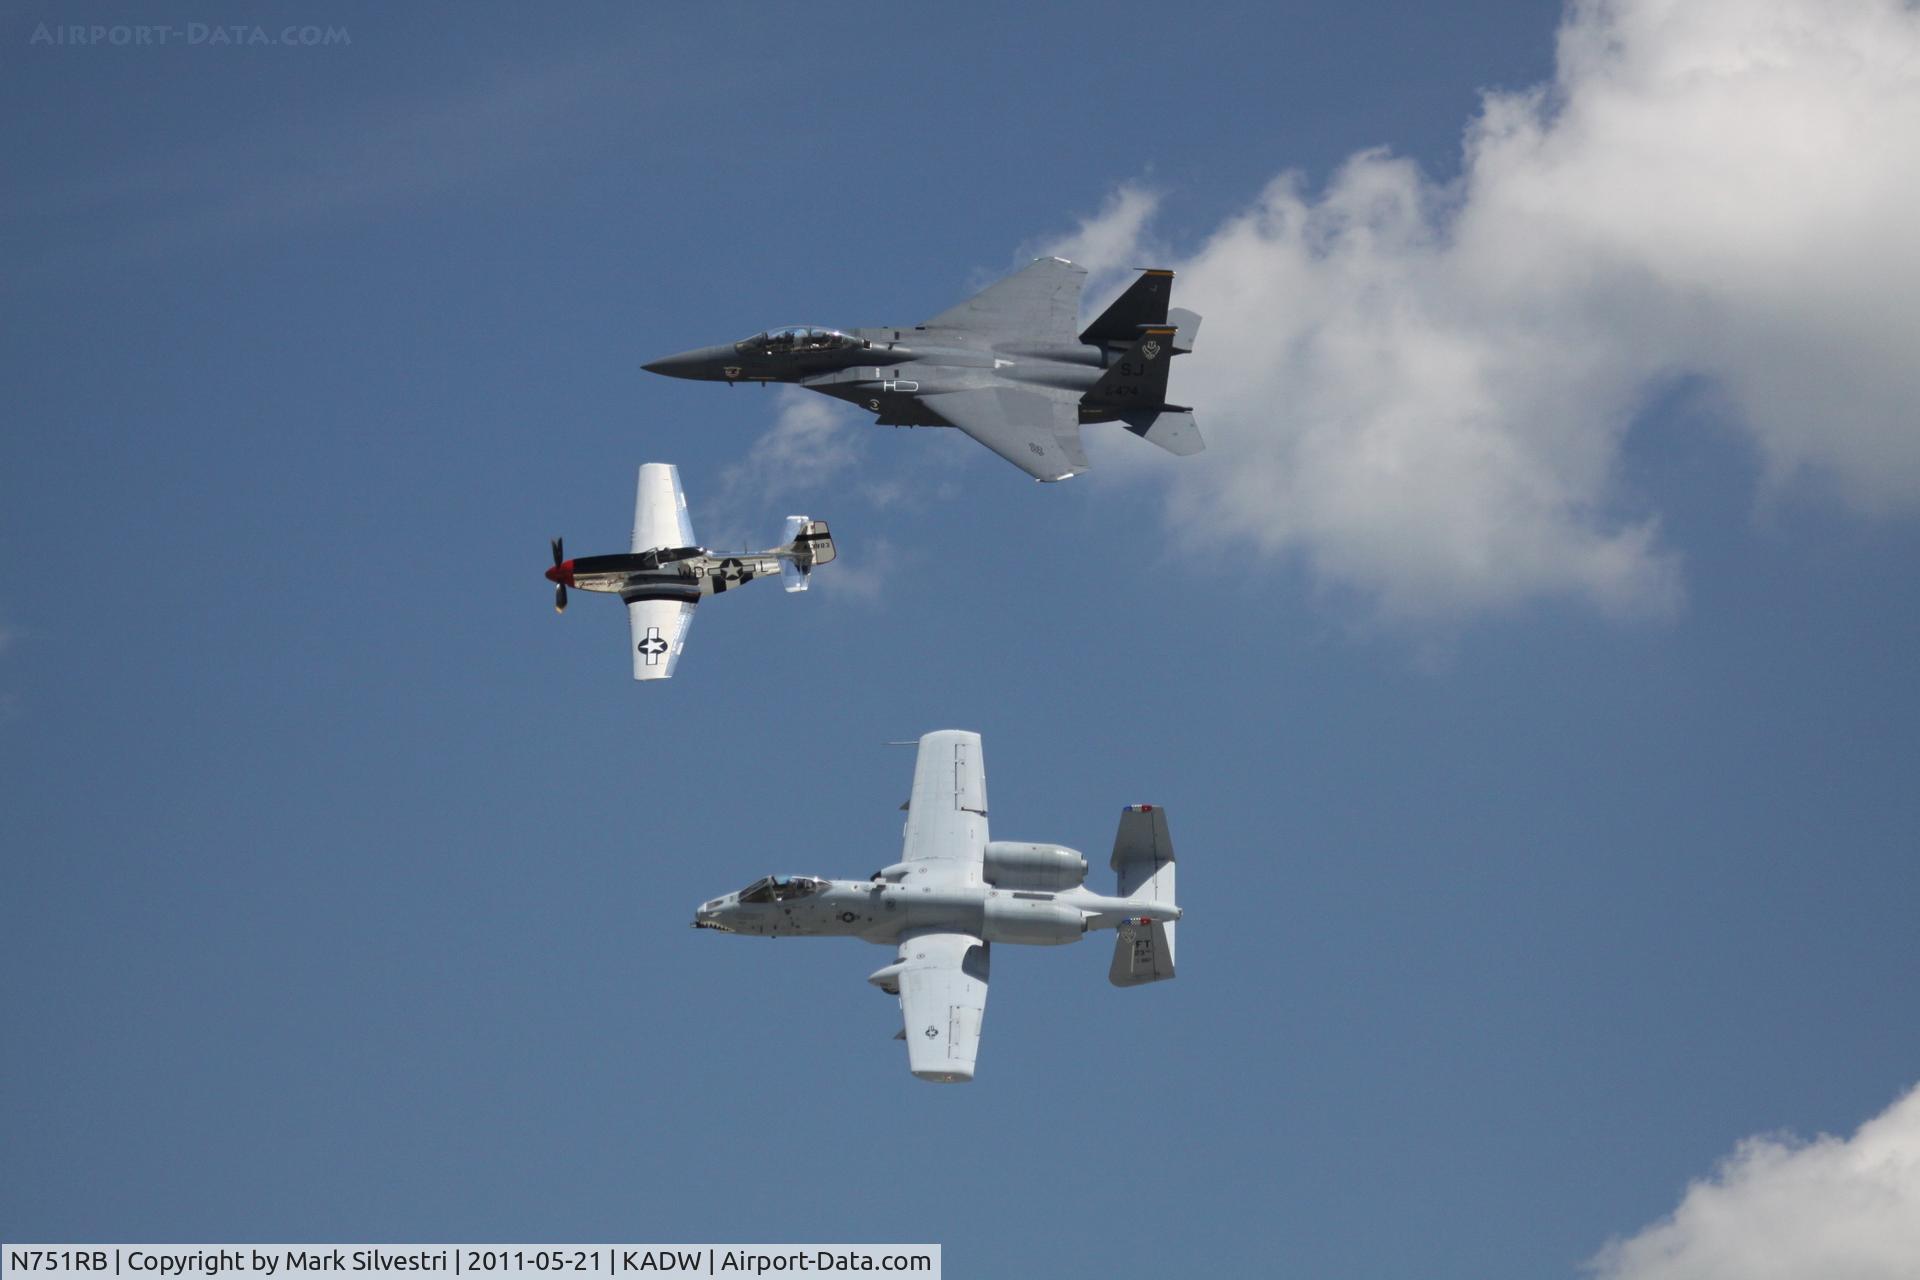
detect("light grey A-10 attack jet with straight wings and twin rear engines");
top-left (693, 729), bottom-right (1181, 1084)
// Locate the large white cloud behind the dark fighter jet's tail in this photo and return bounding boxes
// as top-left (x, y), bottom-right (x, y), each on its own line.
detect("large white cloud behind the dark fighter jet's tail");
top-left (1056, 0), bottom-right (1920, 618)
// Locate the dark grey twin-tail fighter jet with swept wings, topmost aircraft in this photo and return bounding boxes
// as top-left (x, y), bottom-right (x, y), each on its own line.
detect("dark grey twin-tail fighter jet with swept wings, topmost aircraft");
top-left (645, 257), bottom-right (1206, 480)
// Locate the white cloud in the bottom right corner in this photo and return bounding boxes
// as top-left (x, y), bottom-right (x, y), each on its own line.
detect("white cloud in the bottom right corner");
top-left (1590, 1090), bottom-right (1920, 1280)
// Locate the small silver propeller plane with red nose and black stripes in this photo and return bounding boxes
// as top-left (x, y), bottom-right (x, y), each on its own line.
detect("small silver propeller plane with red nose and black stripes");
top-left (547, 462), bottom-right (833, 679)
